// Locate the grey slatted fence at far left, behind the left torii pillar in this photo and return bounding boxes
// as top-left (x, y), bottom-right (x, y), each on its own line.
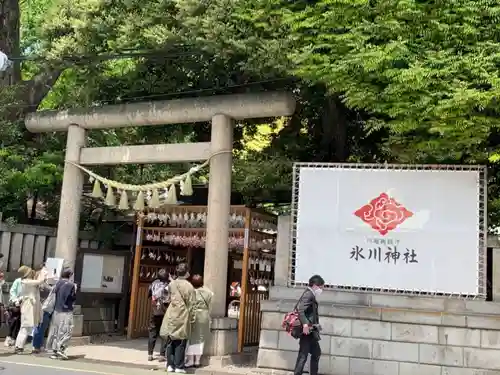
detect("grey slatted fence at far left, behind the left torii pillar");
top-left (0, 223), bottom-right (101, 272)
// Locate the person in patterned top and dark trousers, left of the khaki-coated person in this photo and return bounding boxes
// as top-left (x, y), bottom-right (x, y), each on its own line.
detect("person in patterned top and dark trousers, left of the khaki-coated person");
top-left (148, 269), bottom-right (169, 362)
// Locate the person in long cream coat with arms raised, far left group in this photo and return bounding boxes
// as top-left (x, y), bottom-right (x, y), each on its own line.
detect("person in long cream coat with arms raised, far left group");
top-left (15, 267), bottom-right (45, 353)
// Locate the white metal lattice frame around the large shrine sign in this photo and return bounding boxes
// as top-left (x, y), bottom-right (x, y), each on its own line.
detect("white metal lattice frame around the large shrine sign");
top-left (288, 163), bottom-right (487, 299)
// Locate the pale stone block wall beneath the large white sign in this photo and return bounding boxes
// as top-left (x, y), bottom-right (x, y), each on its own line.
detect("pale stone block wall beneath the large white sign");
top-left (257, 287), bottom-right (500, 375)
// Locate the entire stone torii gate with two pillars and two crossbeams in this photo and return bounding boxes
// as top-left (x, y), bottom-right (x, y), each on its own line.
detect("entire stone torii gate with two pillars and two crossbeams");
top-left (26, 92), bottom-right (295, 340)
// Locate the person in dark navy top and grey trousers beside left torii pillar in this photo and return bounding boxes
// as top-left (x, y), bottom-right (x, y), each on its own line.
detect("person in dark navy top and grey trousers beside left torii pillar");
top-left (47, 268), bottom-right (76, 359)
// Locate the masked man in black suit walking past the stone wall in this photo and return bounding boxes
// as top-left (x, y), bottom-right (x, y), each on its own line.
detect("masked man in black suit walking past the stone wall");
top-left (293, 275), bottom-right (325, 375)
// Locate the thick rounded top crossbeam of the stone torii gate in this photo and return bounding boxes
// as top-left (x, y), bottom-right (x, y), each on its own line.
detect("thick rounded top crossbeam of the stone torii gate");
top-left (25, 92), bottom-right (295, 133)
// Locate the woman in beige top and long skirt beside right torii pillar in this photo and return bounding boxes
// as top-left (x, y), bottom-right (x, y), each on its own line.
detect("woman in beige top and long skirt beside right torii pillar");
top-left (186, 275), bottom-right (213, 367)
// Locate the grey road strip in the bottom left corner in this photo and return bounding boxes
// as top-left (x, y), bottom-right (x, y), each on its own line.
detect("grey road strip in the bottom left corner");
top-left (0, 355), bottom-right (157, 375)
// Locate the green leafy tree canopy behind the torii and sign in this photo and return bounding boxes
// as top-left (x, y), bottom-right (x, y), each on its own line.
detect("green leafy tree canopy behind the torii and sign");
top-left (0, 0), bottom-right (500, 227)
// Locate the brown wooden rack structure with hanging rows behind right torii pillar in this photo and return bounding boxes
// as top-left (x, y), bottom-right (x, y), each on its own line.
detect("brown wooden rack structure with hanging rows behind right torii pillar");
top-left (128, 206), bottom-right (277, 351)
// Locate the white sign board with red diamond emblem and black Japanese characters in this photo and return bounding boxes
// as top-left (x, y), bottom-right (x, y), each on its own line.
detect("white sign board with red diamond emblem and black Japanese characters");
top-left (295, 166), bottom-right (484, 295)
